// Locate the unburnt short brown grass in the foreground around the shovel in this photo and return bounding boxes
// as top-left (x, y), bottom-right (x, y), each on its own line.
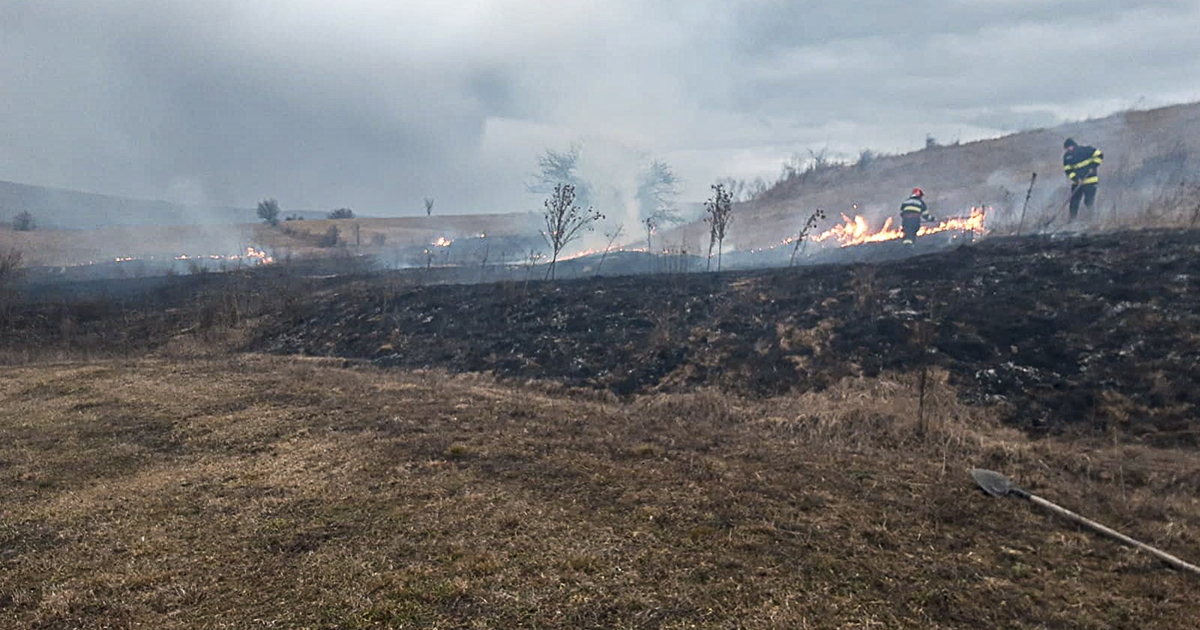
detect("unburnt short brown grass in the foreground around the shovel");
top-left (0, 356), bottom-right (1200, 628)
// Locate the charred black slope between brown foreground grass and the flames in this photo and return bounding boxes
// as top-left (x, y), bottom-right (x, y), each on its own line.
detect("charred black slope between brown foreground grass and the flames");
top-left (250, 230), bottom-right (1200, 445)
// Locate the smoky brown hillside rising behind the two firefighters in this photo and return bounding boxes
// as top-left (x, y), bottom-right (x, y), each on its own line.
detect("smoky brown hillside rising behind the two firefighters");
top-left (661, 103), bottom-right (1200, 250)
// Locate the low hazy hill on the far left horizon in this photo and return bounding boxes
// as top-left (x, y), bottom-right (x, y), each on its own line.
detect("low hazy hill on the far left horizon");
top-left (0, 181), bottom-right (325, 229)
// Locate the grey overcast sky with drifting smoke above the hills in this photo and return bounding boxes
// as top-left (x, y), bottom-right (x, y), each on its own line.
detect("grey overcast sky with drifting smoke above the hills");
top-left (0, 0), bottom-right (1200, 215)
